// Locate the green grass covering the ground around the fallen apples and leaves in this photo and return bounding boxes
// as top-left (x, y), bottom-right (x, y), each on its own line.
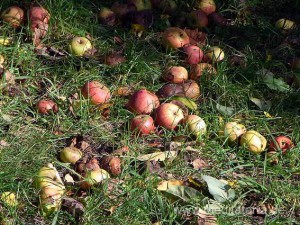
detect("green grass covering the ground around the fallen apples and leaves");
top-left (0, 0), bottom-right (300, 225)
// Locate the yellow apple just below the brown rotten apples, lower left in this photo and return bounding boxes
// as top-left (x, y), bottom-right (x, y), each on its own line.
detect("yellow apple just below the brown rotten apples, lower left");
top-left (80, 169), bottom-right (110, 190)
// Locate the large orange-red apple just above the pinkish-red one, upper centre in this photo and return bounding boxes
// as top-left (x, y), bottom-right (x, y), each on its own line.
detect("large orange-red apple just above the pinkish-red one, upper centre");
top-left (162, 27), bottom-right (190, 49)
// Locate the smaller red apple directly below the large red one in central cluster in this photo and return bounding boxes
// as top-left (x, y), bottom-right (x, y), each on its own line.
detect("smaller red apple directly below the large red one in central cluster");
top-left (130, 115), bottom-right (155, 136)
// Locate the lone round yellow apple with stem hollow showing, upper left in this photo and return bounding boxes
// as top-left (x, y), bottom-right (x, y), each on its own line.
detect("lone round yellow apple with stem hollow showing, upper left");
top-left (69, 37), bottom-right (93, 56)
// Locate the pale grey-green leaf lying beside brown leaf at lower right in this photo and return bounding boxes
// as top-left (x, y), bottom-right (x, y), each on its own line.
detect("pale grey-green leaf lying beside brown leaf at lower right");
top-left (201, 175), bottom-right (235, 203)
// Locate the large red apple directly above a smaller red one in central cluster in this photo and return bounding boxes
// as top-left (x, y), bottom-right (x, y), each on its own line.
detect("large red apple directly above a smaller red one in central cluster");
top-left (126, 89), bottom-right (160, 114)
